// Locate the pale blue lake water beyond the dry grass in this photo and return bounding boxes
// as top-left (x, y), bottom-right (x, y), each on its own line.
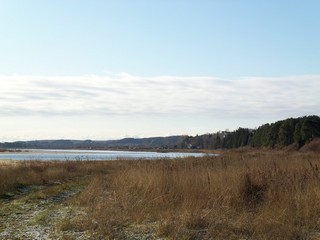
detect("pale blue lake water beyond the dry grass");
top-left (0, 149), bottom-right (214, 161)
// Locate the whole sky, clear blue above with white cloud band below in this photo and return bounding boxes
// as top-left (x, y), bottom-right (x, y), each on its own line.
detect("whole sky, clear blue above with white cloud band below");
top-left (0, 0), bottom-right (320, 142)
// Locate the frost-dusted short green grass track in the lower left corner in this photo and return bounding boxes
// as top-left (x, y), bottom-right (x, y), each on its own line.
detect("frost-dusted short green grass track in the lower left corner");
top-left (0, 183), bottom-right (89, 240)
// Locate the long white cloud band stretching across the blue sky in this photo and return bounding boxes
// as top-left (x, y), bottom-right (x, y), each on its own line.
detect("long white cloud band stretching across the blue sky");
top-left (0, 73), bottom-right (320, 118)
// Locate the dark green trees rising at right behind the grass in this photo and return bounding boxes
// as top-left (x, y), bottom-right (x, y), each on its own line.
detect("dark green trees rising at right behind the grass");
top-left (181, 115), bottom-right (320, 149)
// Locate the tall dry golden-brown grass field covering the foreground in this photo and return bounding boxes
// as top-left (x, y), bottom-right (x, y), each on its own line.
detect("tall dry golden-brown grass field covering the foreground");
top-left (0, 150), bottom-right (320, 240)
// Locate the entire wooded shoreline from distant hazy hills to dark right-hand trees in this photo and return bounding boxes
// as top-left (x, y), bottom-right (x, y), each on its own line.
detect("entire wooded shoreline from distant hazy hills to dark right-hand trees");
top-left (0, 115), bottom-right (320, 150)
